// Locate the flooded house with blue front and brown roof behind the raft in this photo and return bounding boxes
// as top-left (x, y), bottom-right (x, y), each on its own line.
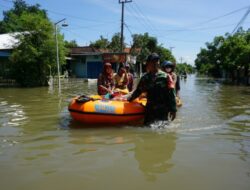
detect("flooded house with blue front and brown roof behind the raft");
top-left (67, 46), bottom-right (127, 79)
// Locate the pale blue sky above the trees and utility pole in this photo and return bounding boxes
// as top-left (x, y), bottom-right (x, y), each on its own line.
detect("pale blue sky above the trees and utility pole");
top-left (0, 0), bottom-right (250, 65)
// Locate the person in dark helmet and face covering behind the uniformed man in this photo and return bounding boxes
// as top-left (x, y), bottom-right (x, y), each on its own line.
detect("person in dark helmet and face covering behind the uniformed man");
top-left (161, 61), bottom-right (181, 98)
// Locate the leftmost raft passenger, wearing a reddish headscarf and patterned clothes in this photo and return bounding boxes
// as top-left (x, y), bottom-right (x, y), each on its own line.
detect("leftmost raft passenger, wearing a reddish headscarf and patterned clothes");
top-left (97, 63), bottom-right (115, 95)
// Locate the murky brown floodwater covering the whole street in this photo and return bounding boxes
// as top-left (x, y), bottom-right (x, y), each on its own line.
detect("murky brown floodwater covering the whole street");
top-left (0, 76), bottom-right (250, 190)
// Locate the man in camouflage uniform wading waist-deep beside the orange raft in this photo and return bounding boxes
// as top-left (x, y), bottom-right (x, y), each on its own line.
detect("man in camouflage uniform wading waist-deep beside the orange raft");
top-left (128, 53), bottom-right (177, 125)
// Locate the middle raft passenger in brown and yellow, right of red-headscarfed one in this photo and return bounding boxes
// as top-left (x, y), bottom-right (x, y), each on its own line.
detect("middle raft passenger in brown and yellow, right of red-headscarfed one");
top-left (114, 64), bottom-right (129, 94)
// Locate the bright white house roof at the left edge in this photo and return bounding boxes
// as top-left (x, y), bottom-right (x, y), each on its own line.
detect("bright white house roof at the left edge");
top-left (0, 32), bottom-right (19, 50)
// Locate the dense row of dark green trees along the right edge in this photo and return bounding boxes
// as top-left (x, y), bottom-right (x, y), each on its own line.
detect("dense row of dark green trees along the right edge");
top-left (195, 28), bottom-right (250, 84)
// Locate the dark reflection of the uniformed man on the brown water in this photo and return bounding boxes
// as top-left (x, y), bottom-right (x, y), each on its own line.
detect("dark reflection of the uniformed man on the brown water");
top-left (134, 133), bottom-right (177, 181)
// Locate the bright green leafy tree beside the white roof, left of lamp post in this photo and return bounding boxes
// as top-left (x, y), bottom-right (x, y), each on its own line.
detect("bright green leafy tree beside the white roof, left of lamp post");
top-left (11, 13), bottom-right (55, 87)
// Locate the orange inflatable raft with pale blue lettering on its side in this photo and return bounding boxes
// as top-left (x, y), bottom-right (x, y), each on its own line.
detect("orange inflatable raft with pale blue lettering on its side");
top-left (68, 95), bottom-right (146, 124)
